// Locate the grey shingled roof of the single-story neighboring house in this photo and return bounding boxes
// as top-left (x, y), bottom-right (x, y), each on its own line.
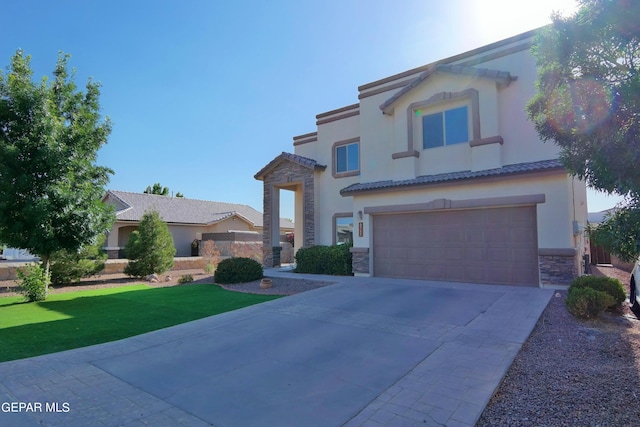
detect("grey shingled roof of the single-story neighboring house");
top-left (103, 190), bottom-right (293, 228)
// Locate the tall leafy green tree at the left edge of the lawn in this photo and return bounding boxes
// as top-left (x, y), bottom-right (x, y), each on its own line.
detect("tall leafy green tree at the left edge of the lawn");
top-left (0, 50), bottom-right (115, 277)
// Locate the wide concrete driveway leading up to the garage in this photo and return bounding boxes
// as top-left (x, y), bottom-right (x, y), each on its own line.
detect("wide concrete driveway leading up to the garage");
top-left (0, 270), bottom-right (553, 426)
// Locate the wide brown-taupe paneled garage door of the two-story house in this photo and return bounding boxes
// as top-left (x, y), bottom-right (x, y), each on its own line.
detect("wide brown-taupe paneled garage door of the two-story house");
top-left (373, 206), bottom-right (538, 286)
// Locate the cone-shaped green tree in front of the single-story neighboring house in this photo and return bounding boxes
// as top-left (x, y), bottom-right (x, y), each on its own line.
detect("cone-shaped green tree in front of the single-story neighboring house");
top-left (124, 211), bottom-right (176, 277)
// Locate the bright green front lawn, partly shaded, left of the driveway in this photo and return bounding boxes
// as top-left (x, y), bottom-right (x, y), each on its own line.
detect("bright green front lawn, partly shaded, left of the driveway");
top-left (0, 285), bottom-right (279, 362)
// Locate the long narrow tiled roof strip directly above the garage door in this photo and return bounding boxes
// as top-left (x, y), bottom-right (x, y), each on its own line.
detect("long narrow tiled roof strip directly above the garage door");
top-left (340, 159), bottom-right (563, 196)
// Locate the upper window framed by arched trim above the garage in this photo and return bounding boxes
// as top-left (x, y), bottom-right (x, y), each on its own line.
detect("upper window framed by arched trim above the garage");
top-left (422, 106), bottom-right (469, 148)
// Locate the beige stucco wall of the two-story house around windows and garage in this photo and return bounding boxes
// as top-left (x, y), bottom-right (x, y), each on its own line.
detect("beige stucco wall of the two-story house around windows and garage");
top-left (295, 32), bottom-right (587, 280)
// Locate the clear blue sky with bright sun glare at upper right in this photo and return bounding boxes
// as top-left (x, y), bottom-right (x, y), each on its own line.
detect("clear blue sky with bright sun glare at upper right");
top-left (0, 0), bottom-right (618, 218)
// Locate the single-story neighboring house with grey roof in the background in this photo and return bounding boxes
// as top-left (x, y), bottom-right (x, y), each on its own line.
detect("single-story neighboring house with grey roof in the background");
top-left (102, 190), bottom-right (294, 258)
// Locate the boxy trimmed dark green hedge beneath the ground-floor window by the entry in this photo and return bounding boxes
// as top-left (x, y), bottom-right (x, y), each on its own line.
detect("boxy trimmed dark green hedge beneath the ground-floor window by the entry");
top-left (296, 245), bottom-right (352, 276)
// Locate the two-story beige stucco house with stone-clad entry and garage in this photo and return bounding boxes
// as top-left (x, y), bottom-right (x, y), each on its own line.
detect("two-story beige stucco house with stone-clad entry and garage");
top-left (255, 31), bottom-right (587, 286)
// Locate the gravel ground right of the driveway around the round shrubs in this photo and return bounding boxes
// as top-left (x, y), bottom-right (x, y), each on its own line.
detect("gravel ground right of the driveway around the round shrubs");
top-left (476, 267), bottom-right (640, 427)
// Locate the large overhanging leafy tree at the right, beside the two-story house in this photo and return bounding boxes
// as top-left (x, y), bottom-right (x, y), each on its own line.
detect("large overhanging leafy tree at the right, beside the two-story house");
top-left (527, 0), bottom-right (640, 260)
